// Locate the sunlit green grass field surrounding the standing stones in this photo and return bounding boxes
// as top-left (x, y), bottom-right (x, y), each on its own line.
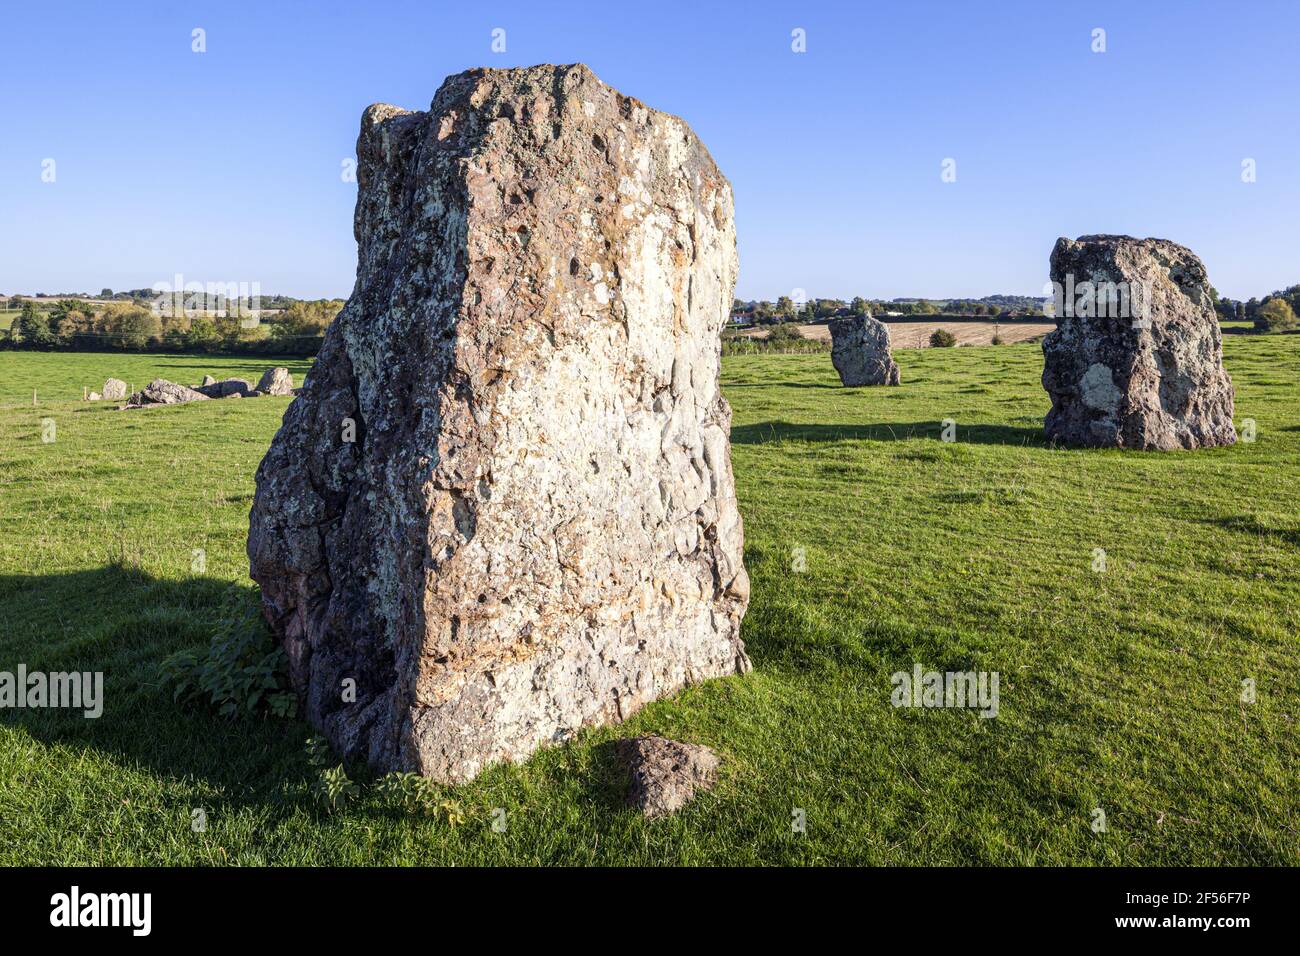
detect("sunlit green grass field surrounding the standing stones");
top-left (0, 336), bottom-right (1300, 865)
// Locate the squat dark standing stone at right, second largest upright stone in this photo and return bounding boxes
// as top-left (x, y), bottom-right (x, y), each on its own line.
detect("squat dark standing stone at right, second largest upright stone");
top-left (1043, 235), bottom-right (1236, 450)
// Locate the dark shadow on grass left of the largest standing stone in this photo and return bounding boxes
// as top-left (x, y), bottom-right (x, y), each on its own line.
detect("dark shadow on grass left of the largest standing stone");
top-left (0, 564), bottom-right (311, 801)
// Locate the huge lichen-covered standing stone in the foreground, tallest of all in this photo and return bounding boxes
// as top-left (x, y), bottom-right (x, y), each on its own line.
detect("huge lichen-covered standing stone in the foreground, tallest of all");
top-left (248, 65), bottom-right (749, 780)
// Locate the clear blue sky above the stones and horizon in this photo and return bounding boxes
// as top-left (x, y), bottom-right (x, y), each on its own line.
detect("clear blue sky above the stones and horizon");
top-left (0, 0), bottom-right (1300, 299)
